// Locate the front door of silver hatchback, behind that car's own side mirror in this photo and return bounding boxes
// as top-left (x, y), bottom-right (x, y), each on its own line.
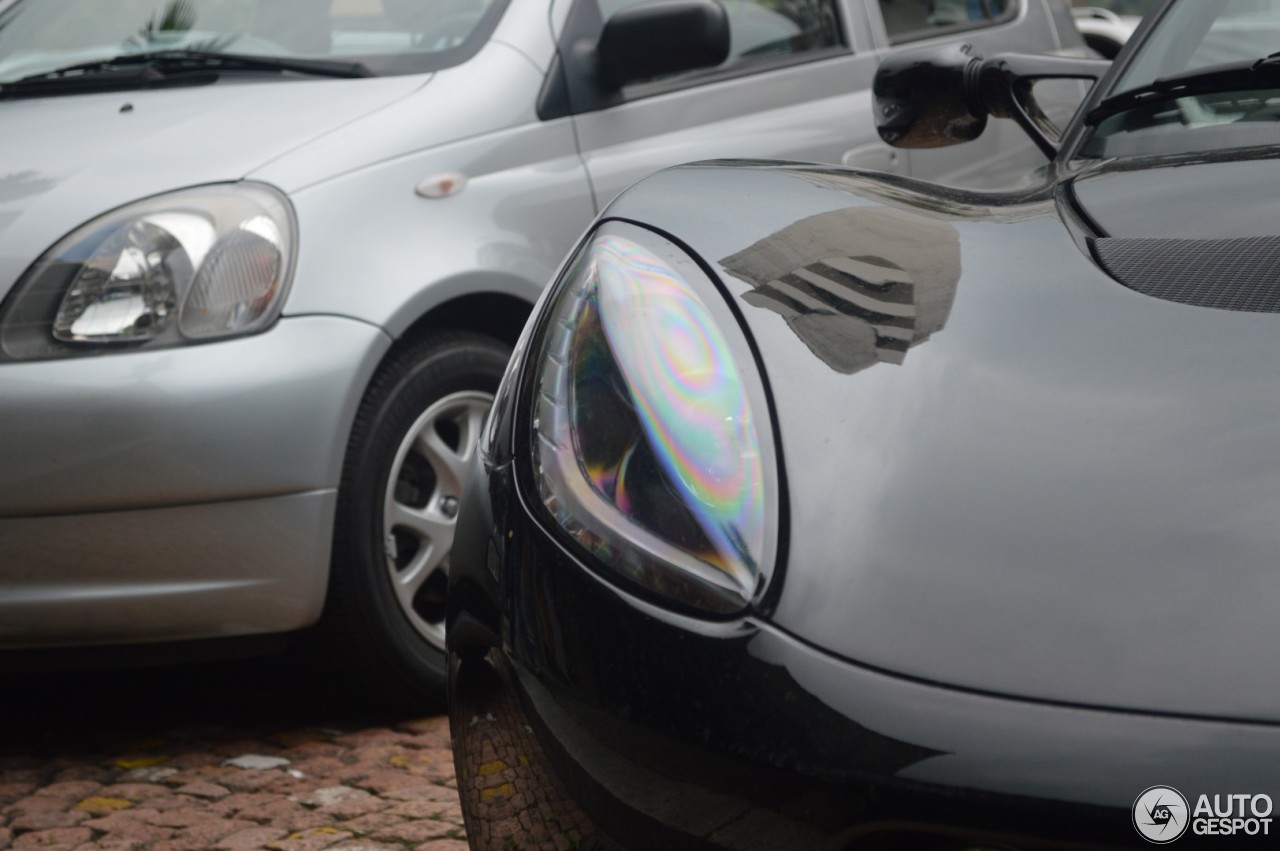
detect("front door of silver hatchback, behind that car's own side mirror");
top-left (553, 0), bottom-right (902, 207)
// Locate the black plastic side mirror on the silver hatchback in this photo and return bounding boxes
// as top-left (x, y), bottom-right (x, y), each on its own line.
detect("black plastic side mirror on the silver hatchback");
top-left (595, 0), bottom-right (730, 90)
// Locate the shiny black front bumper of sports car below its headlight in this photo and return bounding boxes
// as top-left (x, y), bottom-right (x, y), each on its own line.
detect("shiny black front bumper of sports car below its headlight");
top-left (449, 466), bottom-right (1280, 851)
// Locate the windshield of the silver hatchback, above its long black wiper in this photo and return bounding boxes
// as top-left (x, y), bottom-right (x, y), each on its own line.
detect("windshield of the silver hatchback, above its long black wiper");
top-left (0, 0), bottom-right (504, 83)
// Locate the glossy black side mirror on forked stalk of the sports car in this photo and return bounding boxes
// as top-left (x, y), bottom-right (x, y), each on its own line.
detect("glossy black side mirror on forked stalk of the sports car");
top-left (872, 45), bottom-right (1111, 159)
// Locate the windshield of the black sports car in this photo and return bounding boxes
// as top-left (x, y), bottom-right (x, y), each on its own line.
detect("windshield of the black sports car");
top-left (1080, 0), bottom-right (1280, 157)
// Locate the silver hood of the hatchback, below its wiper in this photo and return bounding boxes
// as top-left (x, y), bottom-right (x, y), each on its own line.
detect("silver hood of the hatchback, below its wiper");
top-left (0, 76), bottom-right (424, 297)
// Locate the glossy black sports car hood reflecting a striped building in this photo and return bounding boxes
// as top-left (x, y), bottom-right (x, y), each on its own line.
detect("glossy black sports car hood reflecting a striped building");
top-left (607, 164), bottom-right (1280, 720)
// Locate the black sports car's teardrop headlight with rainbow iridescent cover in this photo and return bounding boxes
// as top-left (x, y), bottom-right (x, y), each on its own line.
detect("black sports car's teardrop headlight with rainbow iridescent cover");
top-left (532, 223), bottom-right (778, 614)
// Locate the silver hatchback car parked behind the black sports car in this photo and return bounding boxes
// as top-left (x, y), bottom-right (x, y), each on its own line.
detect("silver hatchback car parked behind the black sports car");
top-left (0, 0), bottom-right (1080, 692)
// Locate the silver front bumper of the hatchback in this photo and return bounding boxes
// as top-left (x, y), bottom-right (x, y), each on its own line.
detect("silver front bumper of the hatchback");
top-left (0, 316), bottom-right (389, 648)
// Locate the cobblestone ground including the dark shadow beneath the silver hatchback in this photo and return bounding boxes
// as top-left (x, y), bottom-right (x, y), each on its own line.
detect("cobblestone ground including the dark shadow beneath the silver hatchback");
top-left (0, 650), bottom-right (467, 851)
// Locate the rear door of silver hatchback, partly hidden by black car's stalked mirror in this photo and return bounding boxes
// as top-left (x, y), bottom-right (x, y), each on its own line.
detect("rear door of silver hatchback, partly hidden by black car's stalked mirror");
top-left (867, 0), bottom-right (1085, 188)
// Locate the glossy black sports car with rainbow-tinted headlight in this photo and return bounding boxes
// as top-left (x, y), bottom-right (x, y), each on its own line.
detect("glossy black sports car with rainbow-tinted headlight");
top-left (448, 0), bottom-right (1280, 851)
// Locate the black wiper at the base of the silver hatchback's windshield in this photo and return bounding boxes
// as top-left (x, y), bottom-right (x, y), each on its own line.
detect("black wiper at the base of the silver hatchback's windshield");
top-left (0, 50), bottom-right (372, 97)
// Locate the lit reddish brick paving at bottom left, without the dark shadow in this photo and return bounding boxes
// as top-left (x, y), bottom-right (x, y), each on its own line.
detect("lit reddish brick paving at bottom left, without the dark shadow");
top-left (0, 717), bottom-right (466, 851)
